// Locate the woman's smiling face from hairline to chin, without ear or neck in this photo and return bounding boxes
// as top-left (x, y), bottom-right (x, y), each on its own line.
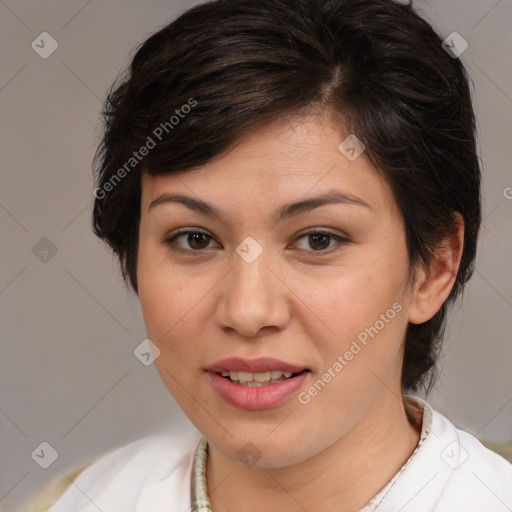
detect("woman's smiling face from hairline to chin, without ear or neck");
top-left (137, 116), bottom-right (418, 467)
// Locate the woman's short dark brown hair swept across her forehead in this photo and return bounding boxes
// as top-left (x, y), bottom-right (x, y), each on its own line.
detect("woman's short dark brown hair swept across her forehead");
top-left (93, 0), bottom-right (481, 391)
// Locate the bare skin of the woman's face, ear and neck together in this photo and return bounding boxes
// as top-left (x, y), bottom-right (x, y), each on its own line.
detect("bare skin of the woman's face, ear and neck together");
top-left (137, 116), bottom-right (463, 512)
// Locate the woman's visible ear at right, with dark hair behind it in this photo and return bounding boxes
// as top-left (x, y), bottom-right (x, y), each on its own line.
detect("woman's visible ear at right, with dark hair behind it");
top-left (408, 212), bottom-right (464, 324)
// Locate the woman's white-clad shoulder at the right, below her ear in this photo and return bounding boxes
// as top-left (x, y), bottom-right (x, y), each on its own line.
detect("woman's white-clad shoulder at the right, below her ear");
top-left (379, 399), bottom-right (512, 512)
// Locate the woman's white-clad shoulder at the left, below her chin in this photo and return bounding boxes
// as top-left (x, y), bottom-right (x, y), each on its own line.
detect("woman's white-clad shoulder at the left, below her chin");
top-left (22, 429), bottom-right (201, 512)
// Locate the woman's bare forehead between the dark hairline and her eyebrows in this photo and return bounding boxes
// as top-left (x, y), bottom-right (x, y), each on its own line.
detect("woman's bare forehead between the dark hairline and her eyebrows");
top-left (141, 115), bottom-right (397, 219)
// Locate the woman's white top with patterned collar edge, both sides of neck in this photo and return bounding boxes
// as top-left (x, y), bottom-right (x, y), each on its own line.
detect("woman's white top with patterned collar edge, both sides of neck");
top-left (44, 397), bottom-right (512, 512)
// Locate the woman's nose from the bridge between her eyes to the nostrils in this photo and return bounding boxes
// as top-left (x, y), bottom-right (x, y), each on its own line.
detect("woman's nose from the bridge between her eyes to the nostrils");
top-left (219, 237), bottom-right (288, 336)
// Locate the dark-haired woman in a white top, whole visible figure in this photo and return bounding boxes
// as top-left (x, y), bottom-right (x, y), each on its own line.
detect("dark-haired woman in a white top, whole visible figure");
top-left (25, 0), bottom-right (512, 512)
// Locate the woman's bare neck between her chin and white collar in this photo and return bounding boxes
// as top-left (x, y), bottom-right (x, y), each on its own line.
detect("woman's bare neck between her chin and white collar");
top-left (207, 393), bottom-right (421, 512)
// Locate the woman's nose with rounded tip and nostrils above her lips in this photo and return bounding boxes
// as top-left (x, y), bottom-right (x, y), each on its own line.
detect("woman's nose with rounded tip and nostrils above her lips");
top-left (217, 246), bottom-right (291, 337)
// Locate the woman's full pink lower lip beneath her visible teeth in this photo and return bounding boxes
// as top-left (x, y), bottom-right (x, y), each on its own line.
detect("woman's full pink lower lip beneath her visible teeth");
top-left (208, 371), bottom-right (309, 411)
